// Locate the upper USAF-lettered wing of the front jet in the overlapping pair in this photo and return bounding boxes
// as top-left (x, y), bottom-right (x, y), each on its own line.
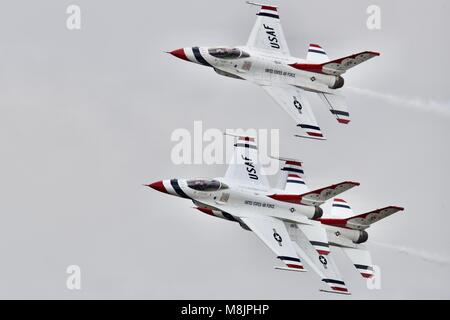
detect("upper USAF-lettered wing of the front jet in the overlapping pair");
top-left (225, 136), bottom-right (270, 189)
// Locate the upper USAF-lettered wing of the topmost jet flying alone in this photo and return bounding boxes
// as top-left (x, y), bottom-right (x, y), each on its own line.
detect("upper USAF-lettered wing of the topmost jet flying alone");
top-left (247, 1), bottom-right (290, 56)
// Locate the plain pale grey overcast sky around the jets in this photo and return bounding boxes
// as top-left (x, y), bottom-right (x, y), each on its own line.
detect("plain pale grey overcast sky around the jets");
top-left (0, 0), bottom-right (450, 299)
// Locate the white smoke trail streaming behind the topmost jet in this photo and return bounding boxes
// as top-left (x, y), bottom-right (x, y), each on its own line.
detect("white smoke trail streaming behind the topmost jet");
top-left (347, 87), bottom-right (450, 117)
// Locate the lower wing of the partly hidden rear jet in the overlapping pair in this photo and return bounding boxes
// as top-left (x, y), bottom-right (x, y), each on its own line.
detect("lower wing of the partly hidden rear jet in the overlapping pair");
top-left (285, 221), bottom-right (349, 294)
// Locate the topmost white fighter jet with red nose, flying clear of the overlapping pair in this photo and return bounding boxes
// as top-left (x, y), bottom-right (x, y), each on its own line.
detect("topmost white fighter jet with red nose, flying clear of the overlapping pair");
top-left (170, 2), bottom-right (379, 140)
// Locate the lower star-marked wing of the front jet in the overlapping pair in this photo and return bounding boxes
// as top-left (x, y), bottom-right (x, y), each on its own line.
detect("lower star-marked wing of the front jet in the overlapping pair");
top-left (240, 216), bottom-right (304, 271)
